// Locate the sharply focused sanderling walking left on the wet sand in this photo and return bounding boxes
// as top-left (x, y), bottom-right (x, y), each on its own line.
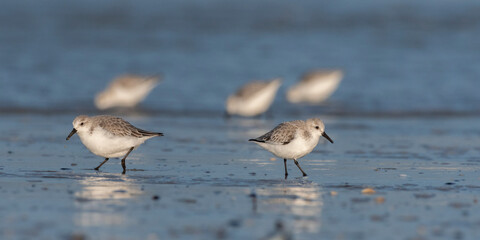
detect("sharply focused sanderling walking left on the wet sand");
top-left (67, 115), bottom-right (163, 174)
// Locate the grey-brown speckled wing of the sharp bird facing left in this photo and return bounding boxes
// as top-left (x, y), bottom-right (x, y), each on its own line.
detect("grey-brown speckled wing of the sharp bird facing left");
top-left (99, 116), bottom-right (163, 138)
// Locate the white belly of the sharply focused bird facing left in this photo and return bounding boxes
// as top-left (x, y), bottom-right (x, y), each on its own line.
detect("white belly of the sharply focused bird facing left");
top-left (79, 128), bottom-right (145, 158)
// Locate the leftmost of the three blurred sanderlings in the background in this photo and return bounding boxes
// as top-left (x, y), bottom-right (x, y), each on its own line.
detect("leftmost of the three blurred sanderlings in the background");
top-left (95, 75), bottom-right (159, 110)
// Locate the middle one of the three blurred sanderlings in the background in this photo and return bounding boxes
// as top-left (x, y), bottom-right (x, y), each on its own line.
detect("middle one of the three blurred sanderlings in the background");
top-left (226, 78), bottom-right (282, 117)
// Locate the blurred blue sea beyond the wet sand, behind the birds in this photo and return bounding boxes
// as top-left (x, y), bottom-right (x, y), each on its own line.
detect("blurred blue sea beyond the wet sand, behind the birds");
top-left (0, 0), bottom-right (480, 114)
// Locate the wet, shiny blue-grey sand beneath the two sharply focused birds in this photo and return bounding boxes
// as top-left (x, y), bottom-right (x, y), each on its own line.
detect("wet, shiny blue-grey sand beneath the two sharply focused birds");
top-left (0, 114), bottom-right (480, 239)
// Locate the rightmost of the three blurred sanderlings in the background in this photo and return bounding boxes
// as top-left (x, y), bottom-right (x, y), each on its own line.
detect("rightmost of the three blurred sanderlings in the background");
top-left (287, 70), bottom-right (343, 104)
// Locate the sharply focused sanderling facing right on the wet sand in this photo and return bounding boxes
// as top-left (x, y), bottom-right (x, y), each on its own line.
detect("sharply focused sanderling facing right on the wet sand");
top-left (248, 118), bottom-right (333, 179)
